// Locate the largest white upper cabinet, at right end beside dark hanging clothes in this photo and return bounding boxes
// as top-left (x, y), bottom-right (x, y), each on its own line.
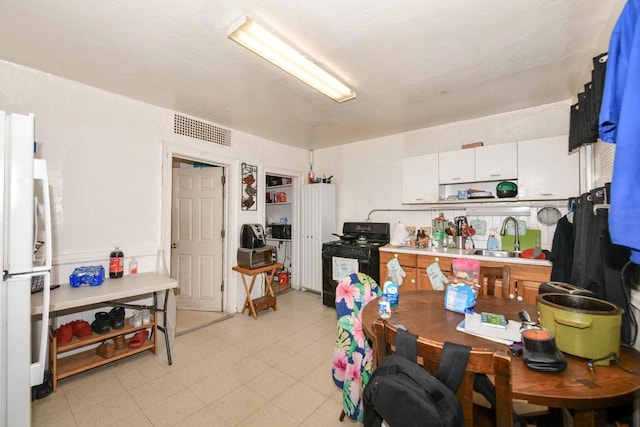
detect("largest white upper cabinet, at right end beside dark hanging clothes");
top-left (518, 135), bottom-right (580, 200)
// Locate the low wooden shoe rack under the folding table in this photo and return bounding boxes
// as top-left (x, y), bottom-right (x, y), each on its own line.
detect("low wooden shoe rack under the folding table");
top-left (49, 312), bottom-right (158, 391)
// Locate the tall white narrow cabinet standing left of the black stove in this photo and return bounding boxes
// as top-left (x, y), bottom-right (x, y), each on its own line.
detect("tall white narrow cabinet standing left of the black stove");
top-left (300, 184), bottom-right (336, 292)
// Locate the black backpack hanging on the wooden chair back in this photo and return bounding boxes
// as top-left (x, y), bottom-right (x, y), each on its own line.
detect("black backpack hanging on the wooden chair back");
top-left (363, 330), bottom-right (471, 427)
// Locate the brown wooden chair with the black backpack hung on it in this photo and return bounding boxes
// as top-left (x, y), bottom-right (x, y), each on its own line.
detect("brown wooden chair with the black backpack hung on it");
top-left (373, 320), bottom-right (513, 427)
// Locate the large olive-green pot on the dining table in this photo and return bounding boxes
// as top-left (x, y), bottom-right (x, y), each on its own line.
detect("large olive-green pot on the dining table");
top-left (537, 293), bottom-right (624, 365)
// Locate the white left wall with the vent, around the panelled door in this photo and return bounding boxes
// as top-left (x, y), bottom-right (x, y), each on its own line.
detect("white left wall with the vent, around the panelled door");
top-left (0, 61), bottom-right (308, 311)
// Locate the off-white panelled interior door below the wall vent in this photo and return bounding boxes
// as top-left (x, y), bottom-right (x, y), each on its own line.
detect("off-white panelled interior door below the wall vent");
top-left (171, 167), bottom-right (223, 311)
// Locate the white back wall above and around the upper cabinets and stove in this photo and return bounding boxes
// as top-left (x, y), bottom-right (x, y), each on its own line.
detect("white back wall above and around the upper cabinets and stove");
top-left (313, 100), bottom-right (570, 249)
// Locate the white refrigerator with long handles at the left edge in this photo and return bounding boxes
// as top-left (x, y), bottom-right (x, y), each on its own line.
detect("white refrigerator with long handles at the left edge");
top-left (0, 111), bottom-right (52, 427)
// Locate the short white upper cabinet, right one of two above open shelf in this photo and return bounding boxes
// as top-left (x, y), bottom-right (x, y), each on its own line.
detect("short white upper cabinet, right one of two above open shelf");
top-left (474, 142), bottom-right (518, 181)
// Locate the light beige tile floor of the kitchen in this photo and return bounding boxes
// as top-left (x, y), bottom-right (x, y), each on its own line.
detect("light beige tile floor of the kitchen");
top-left (32, 291), bottom-right (350, 427)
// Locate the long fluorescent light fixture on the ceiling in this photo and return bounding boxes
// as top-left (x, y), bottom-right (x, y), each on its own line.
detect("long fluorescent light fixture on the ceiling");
top-left (227, 16), bottom-right (356, 102)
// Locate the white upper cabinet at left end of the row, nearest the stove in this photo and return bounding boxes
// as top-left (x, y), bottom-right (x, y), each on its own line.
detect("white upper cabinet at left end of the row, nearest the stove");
top-left (402, 153), bottom-right (438, 204)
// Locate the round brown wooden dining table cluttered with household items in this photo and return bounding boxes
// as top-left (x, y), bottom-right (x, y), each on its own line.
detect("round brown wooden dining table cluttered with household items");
top-left (362, 291), bottom-right (640, 427)
